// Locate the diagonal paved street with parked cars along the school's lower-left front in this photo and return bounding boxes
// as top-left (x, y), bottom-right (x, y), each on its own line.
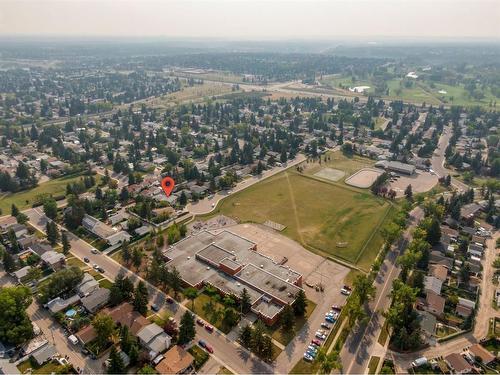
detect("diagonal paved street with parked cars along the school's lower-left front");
top-left (24, 208), bottom-right (274, 374)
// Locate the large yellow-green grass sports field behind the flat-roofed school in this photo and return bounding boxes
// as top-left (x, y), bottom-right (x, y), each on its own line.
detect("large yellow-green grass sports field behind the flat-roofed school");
top-left (207, 171), bottom-right (390, 268)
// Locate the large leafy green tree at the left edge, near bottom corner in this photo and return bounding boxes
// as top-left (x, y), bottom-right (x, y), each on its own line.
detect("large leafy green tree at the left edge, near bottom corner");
top-left (0, 286), bottom-right (33, 345)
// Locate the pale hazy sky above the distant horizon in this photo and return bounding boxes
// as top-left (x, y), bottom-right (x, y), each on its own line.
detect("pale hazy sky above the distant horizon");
top-left (0, 0), bottom-right (500, 39)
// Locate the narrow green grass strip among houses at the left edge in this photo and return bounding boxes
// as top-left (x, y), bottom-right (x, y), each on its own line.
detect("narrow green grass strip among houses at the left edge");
top-left (0, 175), bottom-right (88, 215)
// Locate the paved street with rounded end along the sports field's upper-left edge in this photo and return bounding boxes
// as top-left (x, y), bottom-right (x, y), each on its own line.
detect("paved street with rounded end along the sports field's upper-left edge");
top-left (186, 154), bottom-right (307, 215)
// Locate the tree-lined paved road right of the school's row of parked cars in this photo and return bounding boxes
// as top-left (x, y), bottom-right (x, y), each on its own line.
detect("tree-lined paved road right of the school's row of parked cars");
top-left (340, 207), bottom-right (424, 374)
